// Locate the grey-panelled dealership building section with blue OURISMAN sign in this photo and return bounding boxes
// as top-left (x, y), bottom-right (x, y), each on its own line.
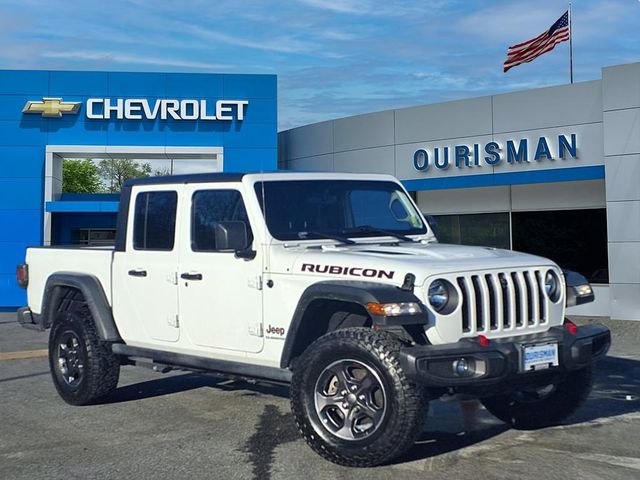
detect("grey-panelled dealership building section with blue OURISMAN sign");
top-left (278, 63), bottom-right (640, 320)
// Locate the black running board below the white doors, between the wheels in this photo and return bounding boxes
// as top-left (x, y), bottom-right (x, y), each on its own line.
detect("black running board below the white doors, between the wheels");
top-left (111, 343), bottom-right (291, 383)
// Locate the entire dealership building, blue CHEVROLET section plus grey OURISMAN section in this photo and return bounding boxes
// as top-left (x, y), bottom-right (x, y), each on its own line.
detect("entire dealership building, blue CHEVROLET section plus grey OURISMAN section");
top-left (0, 63), bottom-right (640, 320)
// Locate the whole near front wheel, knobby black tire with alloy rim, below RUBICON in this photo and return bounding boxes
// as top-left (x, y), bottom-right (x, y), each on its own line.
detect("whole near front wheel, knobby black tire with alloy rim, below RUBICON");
top-left (291, 328), bottom-right (426, 467)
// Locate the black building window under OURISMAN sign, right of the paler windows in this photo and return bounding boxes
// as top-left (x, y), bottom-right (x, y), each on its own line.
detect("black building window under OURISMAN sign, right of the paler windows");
top-left (511, 208), bottom-right (609, 283)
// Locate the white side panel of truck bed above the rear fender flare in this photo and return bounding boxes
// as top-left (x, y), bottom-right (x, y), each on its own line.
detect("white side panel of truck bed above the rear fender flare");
top-left (26, 246), bottom-right (113, 314)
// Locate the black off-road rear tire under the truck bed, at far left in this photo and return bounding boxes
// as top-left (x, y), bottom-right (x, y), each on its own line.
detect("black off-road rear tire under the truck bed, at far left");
top-left (49, 305), bottom-right (120, 405)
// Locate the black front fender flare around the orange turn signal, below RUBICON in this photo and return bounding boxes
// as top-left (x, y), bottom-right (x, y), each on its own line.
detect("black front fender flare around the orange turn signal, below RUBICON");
top-left (280, 280), bottom-right (434, 368)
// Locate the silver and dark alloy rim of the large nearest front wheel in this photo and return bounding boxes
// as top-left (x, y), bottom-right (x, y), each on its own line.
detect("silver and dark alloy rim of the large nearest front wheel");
top-left (314, 359), bottom-right (387, 441)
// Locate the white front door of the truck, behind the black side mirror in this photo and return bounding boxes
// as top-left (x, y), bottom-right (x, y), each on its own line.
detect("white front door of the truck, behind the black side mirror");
top-left (178, 184), bottom-right (263, 352)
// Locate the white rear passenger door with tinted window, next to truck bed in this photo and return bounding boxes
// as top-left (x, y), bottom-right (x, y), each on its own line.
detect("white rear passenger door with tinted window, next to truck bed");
top-left (113, 185), bottom-right (183, 343)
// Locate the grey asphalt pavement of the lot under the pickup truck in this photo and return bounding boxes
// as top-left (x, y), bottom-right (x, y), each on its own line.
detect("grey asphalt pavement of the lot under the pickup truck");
top-left (0, 313), bottom-right (640, 480)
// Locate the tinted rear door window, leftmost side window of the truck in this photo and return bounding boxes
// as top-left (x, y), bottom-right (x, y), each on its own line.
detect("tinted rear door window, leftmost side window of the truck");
top-left (133, 191), bottom-right (178, 250)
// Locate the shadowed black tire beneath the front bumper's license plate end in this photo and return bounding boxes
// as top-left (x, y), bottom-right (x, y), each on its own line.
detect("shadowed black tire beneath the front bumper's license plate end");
top-left (481, 366), bottom-right (593, 430)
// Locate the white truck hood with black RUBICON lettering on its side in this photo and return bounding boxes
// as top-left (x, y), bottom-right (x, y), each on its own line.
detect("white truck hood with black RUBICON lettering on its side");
top-left (271, 242), bottom-right (555, 285)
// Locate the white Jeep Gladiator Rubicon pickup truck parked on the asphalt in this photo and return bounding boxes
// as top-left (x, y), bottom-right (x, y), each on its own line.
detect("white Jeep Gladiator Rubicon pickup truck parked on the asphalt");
top-left (17, 173), bottom-right (610, 466)
